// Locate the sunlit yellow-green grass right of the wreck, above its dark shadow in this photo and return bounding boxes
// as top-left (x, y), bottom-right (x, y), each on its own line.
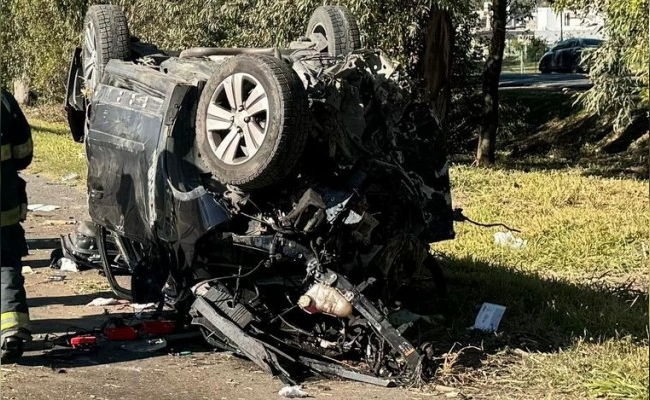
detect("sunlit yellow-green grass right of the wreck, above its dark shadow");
top-left (437, 167), bottom-right (650, 278)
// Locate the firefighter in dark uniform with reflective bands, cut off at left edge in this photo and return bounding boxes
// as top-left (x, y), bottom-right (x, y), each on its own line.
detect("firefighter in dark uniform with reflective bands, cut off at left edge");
top-left (0, 89), bottom-right (33, 363)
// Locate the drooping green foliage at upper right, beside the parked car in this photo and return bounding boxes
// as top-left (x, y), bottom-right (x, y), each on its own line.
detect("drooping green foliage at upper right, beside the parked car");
top-left (555, 0), bottom-right (648, 127)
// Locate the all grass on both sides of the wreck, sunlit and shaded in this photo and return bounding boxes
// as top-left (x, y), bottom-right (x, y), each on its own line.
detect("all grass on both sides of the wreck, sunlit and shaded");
top-left (22, 113), bottom-right (650, 399)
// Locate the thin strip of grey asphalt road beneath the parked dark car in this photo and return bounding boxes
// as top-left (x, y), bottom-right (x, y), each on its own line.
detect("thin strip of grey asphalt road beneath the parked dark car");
top-left (499, 72), bottom-right (592, 90)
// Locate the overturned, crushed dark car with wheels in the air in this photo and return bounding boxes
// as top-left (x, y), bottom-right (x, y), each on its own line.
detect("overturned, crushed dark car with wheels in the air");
top-left (63, 5), bottom-right (454, 385)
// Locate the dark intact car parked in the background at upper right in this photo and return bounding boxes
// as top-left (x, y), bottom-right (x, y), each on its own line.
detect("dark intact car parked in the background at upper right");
top-left (539, 38), bottom-right (604, 74)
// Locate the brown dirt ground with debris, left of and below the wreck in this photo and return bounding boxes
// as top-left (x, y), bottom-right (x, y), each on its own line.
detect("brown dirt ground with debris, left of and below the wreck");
top-left (1, 175), bottom-right (450, 400)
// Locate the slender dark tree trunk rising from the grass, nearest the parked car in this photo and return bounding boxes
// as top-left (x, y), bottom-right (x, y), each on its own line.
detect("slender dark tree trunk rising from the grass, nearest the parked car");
top-left (476, 0), bottom-right (507, 166)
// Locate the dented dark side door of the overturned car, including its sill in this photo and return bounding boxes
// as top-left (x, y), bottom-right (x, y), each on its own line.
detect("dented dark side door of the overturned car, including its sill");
top-left (86, 60), bottom-right (190, 243)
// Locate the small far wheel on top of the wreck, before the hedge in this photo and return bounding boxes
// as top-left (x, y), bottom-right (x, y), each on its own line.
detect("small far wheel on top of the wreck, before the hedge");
top-left (306, 6), bottom-right (361, 57)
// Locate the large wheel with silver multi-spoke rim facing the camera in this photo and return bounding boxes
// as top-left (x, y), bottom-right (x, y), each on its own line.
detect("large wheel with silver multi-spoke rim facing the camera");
top-left (196, 55), bottom-right (311, 190)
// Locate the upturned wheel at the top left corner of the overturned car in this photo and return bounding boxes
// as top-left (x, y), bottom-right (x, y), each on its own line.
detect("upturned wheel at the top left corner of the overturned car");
top-left (81, 4), bottom-right (131, 98)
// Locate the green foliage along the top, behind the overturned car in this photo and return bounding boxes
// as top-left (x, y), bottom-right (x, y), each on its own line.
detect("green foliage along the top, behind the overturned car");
top-left (0, 0), bottom-right (480, 101)
